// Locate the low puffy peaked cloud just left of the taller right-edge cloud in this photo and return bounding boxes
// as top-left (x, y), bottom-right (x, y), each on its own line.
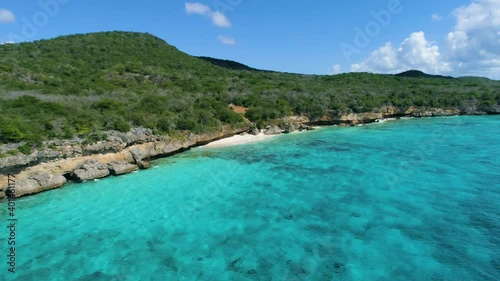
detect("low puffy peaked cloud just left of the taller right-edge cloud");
top-left (351, 31), bottom-right (451, 74)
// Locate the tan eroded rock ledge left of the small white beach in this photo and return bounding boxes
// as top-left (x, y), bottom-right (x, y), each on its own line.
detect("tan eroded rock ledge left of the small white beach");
top-left (0, 124), bottom-right (250, 198)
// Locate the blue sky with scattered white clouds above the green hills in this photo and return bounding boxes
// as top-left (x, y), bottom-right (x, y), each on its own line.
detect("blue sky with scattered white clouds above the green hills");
top-left (0, 0), bottom-right (500, 79)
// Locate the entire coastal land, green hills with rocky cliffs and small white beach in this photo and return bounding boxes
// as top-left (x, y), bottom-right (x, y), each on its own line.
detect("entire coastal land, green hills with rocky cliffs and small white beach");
top-left (0, 32), bottom-right (500, 198)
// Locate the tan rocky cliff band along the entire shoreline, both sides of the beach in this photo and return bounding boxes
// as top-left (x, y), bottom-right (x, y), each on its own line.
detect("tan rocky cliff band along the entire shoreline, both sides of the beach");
top-left (0, 107), bottom-right (500, 199)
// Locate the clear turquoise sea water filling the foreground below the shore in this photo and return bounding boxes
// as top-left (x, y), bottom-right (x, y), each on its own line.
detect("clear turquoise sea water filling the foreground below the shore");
top-left (0, 117), bottom-right (500, 281)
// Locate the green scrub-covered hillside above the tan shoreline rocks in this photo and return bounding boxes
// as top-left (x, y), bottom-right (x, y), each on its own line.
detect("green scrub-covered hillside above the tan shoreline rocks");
top-left (0, 32), bottom-right (500, 147)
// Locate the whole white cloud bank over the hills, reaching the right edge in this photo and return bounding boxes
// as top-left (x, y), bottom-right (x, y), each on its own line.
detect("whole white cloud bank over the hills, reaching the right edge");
top-left (351, 0), bottom-right (500, 79)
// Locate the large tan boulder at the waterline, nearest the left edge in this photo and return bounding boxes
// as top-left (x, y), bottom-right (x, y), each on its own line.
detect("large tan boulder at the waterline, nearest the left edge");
top-left (15, 173), bottom-right (67, 197)
